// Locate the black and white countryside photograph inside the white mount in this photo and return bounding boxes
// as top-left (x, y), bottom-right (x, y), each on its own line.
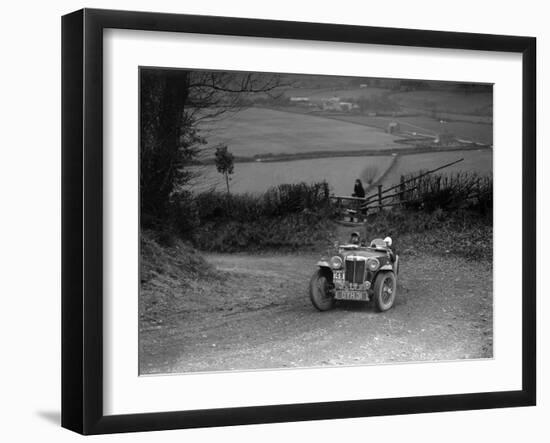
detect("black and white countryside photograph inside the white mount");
top-left (139, 66), bottom-right (496, 376)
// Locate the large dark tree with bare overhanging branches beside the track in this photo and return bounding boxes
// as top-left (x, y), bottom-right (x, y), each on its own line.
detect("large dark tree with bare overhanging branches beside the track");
top-left (140, 68), bottom-right (281, 223)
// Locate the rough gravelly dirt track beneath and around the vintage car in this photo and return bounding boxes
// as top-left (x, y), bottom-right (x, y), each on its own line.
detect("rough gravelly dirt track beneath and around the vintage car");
top-left (140, 250), bottom-right (493, 374)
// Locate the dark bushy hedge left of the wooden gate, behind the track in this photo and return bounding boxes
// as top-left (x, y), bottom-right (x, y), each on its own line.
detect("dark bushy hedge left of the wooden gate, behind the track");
top-left (184, 182), bottom-right (332, 252)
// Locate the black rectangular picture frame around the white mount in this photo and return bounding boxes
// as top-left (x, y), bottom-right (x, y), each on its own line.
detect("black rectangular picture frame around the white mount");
top-left (62, 9), bottom-right (537, 434)
